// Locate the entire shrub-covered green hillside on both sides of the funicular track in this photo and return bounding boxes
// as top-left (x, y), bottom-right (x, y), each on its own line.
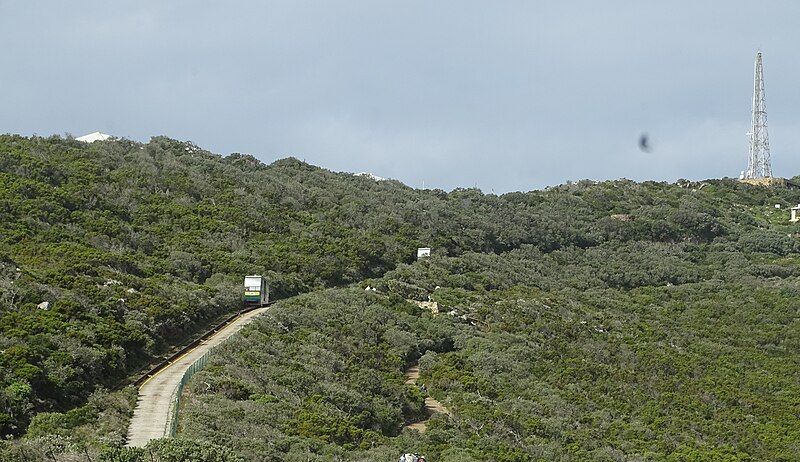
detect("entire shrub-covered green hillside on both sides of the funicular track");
top-left (0, 135), bottom-right (800, 461)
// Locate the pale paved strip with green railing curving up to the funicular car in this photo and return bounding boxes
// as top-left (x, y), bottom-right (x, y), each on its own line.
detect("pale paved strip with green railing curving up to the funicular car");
top-left (127, 307), bottom-right (268, 447)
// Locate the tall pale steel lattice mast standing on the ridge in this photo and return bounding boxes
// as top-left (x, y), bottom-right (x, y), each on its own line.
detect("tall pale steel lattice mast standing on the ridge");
top-left (744, 50), bottom-right (772, 178)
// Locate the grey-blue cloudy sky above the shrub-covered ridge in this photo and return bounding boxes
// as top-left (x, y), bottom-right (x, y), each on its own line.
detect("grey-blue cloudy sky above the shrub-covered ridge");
top-left (0, 0), bottom-right (800, 193)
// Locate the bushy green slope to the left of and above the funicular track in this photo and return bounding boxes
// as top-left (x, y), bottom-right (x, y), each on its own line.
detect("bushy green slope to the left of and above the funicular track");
top-left (0, 135), bottom-right (544, 435)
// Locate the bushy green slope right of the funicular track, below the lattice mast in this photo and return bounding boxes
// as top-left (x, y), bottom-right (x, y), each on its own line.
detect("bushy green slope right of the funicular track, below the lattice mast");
top-left (173, 181), bottom-right (800, 461)
